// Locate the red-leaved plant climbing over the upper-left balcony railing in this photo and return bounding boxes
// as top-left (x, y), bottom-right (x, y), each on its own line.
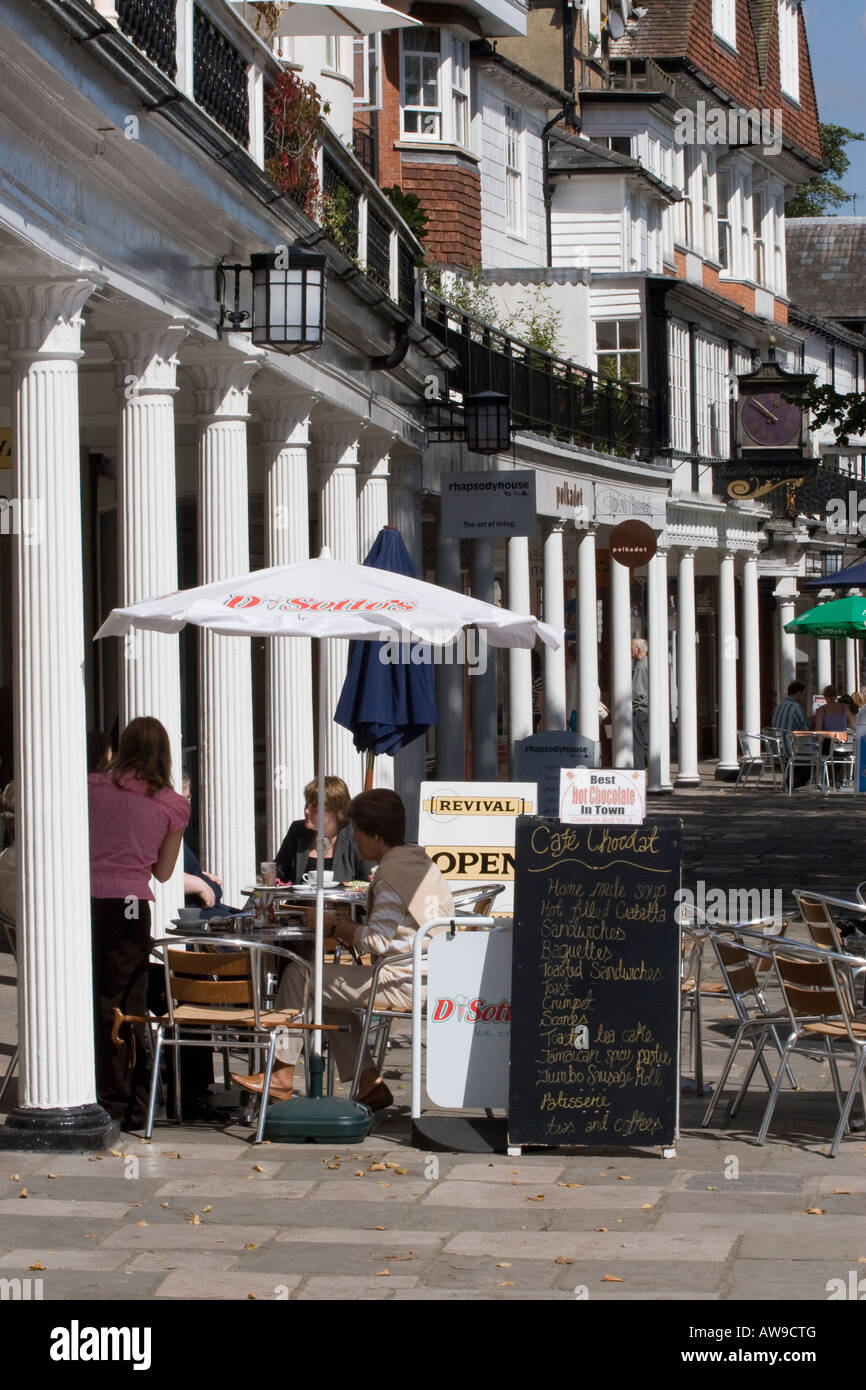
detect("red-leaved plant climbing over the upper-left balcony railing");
top-left (264, 68), bottom-right (329, 213)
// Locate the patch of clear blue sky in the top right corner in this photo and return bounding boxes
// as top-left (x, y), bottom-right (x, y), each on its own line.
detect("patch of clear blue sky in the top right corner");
top-left (803, 0), bottom-right (866, 217)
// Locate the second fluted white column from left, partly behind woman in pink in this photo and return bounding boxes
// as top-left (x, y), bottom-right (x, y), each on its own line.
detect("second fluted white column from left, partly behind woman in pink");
top-left (106, 322), bottom-right (186, 937)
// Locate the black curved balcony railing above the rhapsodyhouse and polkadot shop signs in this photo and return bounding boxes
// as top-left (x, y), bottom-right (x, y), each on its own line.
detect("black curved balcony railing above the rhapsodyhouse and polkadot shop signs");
top-left (424, 295), bottom-right (653, 463)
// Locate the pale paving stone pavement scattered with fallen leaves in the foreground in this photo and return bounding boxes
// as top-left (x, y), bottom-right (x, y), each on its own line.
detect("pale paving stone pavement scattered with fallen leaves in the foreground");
top-left (0, 794), bottom-right (866, 1304)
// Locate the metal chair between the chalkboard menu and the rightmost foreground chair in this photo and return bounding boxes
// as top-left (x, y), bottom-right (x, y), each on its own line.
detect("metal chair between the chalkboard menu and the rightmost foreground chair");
top-left (701, 922), bottom-right (796, 1129)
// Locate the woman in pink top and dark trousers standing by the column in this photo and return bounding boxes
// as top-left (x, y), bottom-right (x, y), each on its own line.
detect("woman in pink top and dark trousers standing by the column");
top-left (88, 719), bottom-right (189, 1129)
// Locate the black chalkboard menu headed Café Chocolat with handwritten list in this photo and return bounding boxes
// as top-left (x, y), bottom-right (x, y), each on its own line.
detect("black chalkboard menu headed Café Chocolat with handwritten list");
top-left (509, 816), bottom-right (683, 1148)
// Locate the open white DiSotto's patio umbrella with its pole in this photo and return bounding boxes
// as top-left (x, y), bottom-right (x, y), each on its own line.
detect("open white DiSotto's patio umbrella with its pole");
top-left (96, 550), bottom-right (563, 1128)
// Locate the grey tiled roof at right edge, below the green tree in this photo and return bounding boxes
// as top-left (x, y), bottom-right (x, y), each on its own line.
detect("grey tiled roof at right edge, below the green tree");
top-left (785, 217), bottom-right (866, 320)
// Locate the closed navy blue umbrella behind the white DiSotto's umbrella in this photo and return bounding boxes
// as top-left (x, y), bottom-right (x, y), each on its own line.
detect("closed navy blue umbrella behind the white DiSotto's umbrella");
top-left (334, 527), bottom-right (436, 781)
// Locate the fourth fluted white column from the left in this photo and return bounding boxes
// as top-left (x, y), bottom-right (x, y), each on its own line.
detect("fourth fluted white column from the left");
top-left (257, 395), bottom-right (316, 858)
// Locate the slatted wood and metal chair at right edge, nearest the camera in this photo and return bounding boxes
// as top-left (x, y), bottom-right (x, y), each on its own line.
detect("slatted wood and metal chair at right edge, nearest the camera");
top-left (758, 952), bottom-right (866, 1158)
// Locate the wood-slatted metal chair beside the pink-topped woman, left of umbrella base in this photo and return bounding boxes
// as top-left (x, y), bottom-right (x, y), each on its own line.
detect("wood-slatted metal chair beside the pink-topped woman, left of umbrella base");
top-left (145, 937), bottom-right (310, 1144)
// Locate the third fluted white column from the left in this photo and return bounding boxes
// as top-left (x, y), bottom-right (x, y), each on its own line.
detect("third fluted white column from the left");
top-left (185, 349), bottom-right (259, 906)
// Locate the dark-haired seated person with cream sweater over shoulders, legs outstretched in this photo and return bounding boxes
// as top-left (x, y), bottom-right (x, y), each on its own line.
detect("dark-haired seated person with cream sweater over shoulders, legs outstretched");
top-left (232, 788), bottom-right (455, 1111)
